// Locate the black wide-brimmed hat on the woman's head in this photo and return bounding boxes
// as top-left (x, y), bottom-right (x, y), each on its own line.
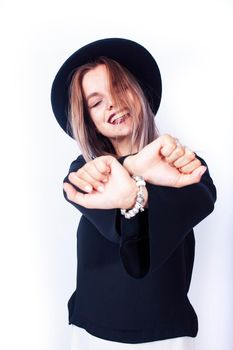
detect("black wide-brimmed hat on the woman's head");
top-left (51, 38), bottom-right (162, 137)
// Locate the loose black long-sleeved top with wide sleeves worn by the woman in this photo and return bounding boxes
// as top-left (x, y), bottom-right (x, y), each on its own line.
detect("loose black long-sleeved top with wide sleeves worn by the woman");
top-left (63, 155), bottom-right (216, 343)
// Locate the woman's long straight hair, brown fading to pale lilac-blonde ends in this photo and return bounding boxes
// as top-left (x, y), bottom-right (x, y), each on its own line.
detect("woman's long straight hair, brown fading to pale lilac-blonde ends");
top-left (67, 57), bottom-right (159, 162)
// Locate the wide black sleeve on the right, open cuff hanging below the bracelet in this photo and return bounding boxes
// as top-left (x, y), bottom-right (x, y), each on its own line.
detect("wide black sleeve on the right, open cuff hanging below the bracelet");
top-left (117, 154), bottom-right (217, 278)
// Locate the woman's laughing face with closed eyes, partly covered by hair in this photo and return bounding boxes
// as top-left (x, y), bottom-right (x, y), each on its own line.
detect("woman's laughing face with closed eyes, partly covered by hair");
top-left (82, 64), bottom-right (137, 151)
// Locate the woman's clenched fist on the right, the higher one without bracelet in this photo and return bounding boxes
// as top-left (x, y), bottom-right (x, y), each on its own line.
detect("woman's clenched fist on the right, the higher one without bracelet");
top-left (124, 134), bottom-right (206, 187)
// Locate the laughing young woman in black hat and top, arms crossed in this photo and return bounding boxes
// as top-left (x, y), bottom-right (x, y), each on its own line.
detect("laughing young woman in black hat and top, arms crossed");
top-left (51, 38), bottom-right (216, 350)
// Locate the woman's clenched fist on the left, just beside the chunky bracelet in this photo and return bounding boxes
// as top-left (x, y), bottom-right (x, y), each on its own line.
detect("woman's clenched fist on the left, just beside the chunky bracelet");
top-left (63, 156), bottom-right (142, 209)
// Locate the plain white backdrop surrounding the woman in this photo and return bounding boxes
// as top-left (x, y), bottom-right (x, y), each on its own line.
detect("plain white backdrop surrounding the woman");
top-left (0, 0), bottom-right (233, 350)
